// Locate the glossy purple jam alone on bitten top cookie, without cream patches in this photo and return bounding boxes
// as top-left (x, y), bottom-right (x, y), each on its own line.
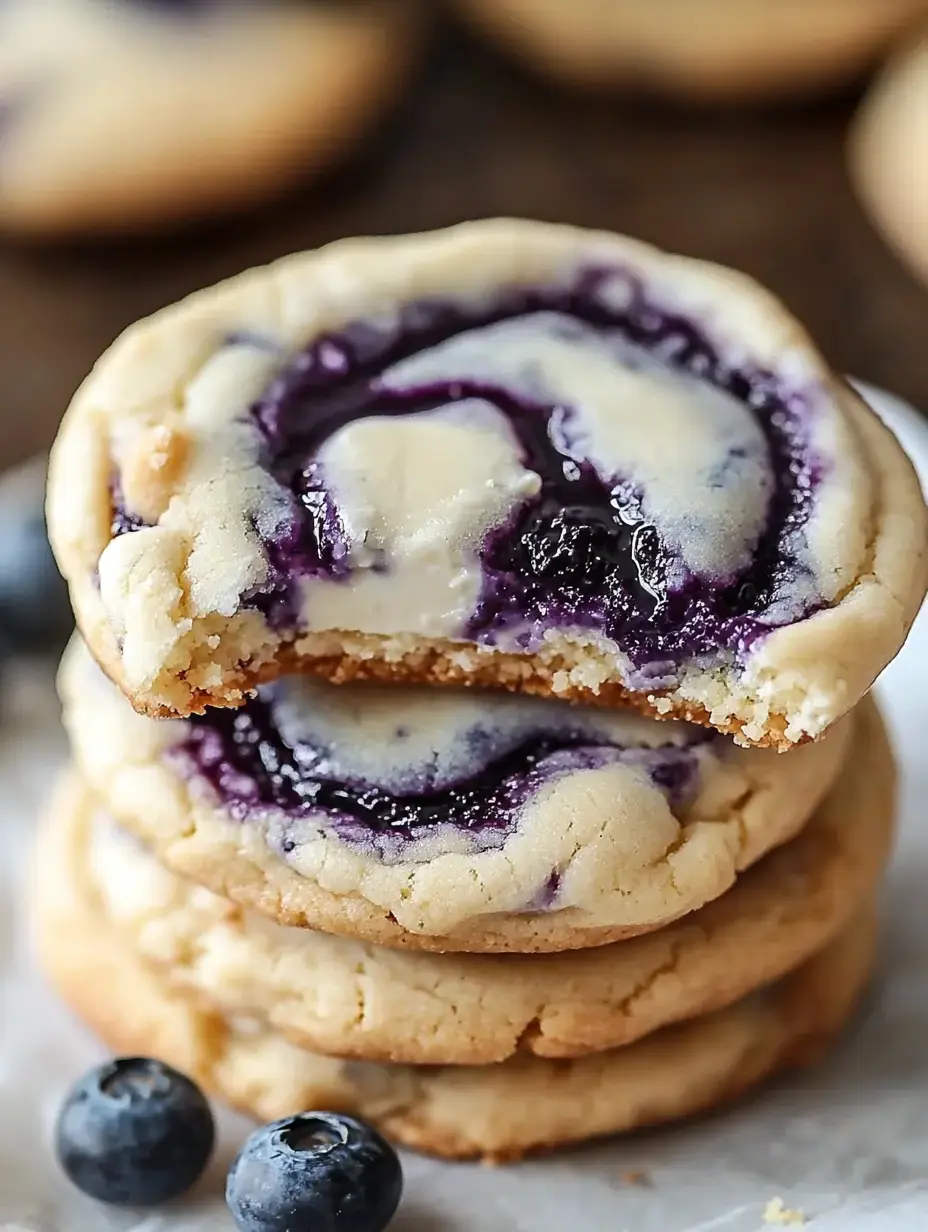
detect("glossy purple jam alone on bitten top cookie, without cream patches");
top-left (113, 269), bottom-right (822, 676)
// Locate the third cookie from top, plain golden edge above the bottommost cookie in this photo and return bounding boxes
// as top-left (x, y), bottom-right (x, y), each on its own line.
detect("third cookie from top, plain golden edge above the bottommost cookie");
top-left (48, 706), bottom-right (893, 1066)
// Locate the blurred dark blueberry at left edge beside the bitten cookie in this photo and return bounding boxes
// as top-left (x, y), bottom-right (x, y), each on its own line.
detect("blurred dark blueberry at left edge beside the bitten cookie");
top-left (0, 458), bottom-right (74, 653)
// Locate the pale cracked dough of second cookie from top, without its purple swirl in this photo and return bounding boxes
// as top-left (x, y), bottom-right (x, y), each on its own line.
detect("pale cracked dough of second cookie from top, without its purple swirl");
top-left (59, 642), bottom-right (854, 951)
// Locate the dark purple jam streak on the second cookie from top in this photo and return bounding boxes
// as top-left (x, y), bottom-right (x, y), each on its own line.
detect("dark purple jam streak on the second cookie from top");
top-left (170, 686), bottom-right (712, 843)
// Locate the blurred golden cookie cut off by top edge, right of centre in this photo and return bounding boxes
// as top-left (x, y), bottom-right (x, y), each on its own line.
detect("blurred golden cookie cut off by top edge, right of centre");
top-left (456, 0), bottom-right (928, 102)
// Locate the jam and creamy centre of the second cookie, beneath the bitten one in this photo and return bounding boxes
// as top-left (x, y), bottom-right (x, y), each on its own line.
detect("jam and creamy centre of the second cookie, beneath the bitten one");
top-left (170, 678), bottom-right (714, 856)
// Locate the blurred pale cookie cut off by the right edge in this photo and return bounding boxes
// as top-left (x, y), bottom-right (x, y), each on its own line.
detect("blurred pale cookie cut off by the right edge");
top-left (849, 41), bottom-right (928, 278)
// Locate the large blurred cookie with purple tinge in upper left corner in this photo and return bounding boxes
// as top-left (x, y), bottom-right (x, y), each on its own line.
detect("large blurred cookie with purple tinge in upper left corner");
top-left (0, 0), bottom-right (415, 235)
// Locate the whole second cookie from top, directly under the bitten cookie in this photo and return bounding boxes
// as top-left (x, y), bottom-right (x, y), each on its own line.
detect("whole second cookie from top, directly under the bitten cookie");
top-left (60, 643), bottom-right (853, 951)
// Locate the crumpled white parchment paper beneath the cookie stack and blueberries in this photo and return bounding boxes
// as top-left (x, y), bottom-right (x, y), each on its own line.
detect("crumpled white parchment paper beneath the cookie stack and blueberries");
top-left (0, 394), bottom-right (928, 1232)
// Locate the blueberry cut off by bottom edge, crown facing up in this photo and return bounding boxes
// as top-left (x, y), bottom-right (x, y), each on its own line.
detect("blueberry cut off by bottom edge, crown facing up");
top-left (226, 1112), bottom-right (403, 1232)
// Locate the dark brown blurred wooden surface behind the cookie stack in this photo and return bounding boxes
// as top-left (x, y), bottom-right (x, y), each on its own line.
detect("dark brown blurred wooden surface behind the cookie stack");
top-left (0, 24), bottom-right (928, 464)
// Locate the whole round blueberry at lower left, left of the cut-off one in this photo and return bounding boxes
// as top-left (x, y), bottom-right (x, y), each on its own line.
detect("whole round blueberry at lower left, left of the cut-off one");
top-left (55, 1057), bottom-right (214, 1206)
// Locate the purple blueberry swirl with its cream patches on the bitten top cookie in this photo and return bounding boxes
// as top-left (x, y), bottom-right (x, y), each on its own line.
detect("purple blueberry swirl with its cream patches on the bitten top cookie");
top-left (213, 269), bottom-right (827, 668)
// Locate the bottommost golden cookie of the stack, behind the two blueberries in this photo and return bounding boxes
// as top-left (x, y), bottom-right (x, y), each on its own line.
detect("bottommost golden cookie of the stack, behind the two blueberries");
top-left (35, 827), bottom-right (875, 1159)
